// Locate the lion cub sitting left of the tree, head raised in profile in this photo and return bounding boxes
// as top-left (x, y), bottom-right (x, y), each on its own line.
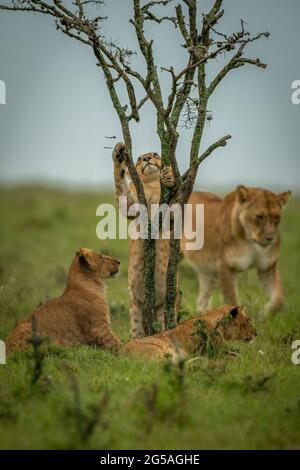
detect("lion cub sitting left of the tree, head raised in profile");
top-left (6, 248), bottom-right (121, 353)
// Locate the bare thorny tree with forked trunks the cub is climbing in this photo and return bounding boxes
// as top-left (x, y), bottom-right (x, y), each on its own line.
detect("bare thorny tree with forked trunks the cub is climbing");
top-left (0, 0), bottom-right (269, 334)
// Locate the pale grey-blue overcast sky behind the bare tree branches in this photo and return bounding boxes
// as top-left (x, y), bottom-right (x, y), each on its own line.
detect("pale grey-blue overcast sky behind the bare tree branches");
top-left (0, 0), bottom-right (300, 189)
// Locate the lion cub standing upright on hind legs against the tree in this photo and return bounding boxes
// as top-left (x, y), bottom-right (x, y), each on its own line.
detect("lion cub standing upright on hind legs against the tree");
top-left (112, 142), bottom-right (180, 338)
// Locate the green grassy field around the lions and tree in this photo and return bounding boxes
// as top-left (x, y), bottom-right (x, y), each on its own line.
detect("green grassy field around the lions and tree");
top-left (0, 188), bottom-right (300, 449)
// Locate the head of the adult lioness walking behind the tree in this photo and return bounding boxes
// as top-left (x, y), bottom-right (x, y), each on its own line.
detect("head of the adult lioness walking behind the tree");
top-left (236, 186), bottom-right (291, 247)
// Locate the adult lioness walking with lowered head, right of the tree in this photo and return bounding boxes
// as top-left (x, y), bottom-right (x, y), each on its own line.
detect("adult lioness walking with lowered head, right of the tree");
top-left (182, 186), bottom-right (291, 316)
